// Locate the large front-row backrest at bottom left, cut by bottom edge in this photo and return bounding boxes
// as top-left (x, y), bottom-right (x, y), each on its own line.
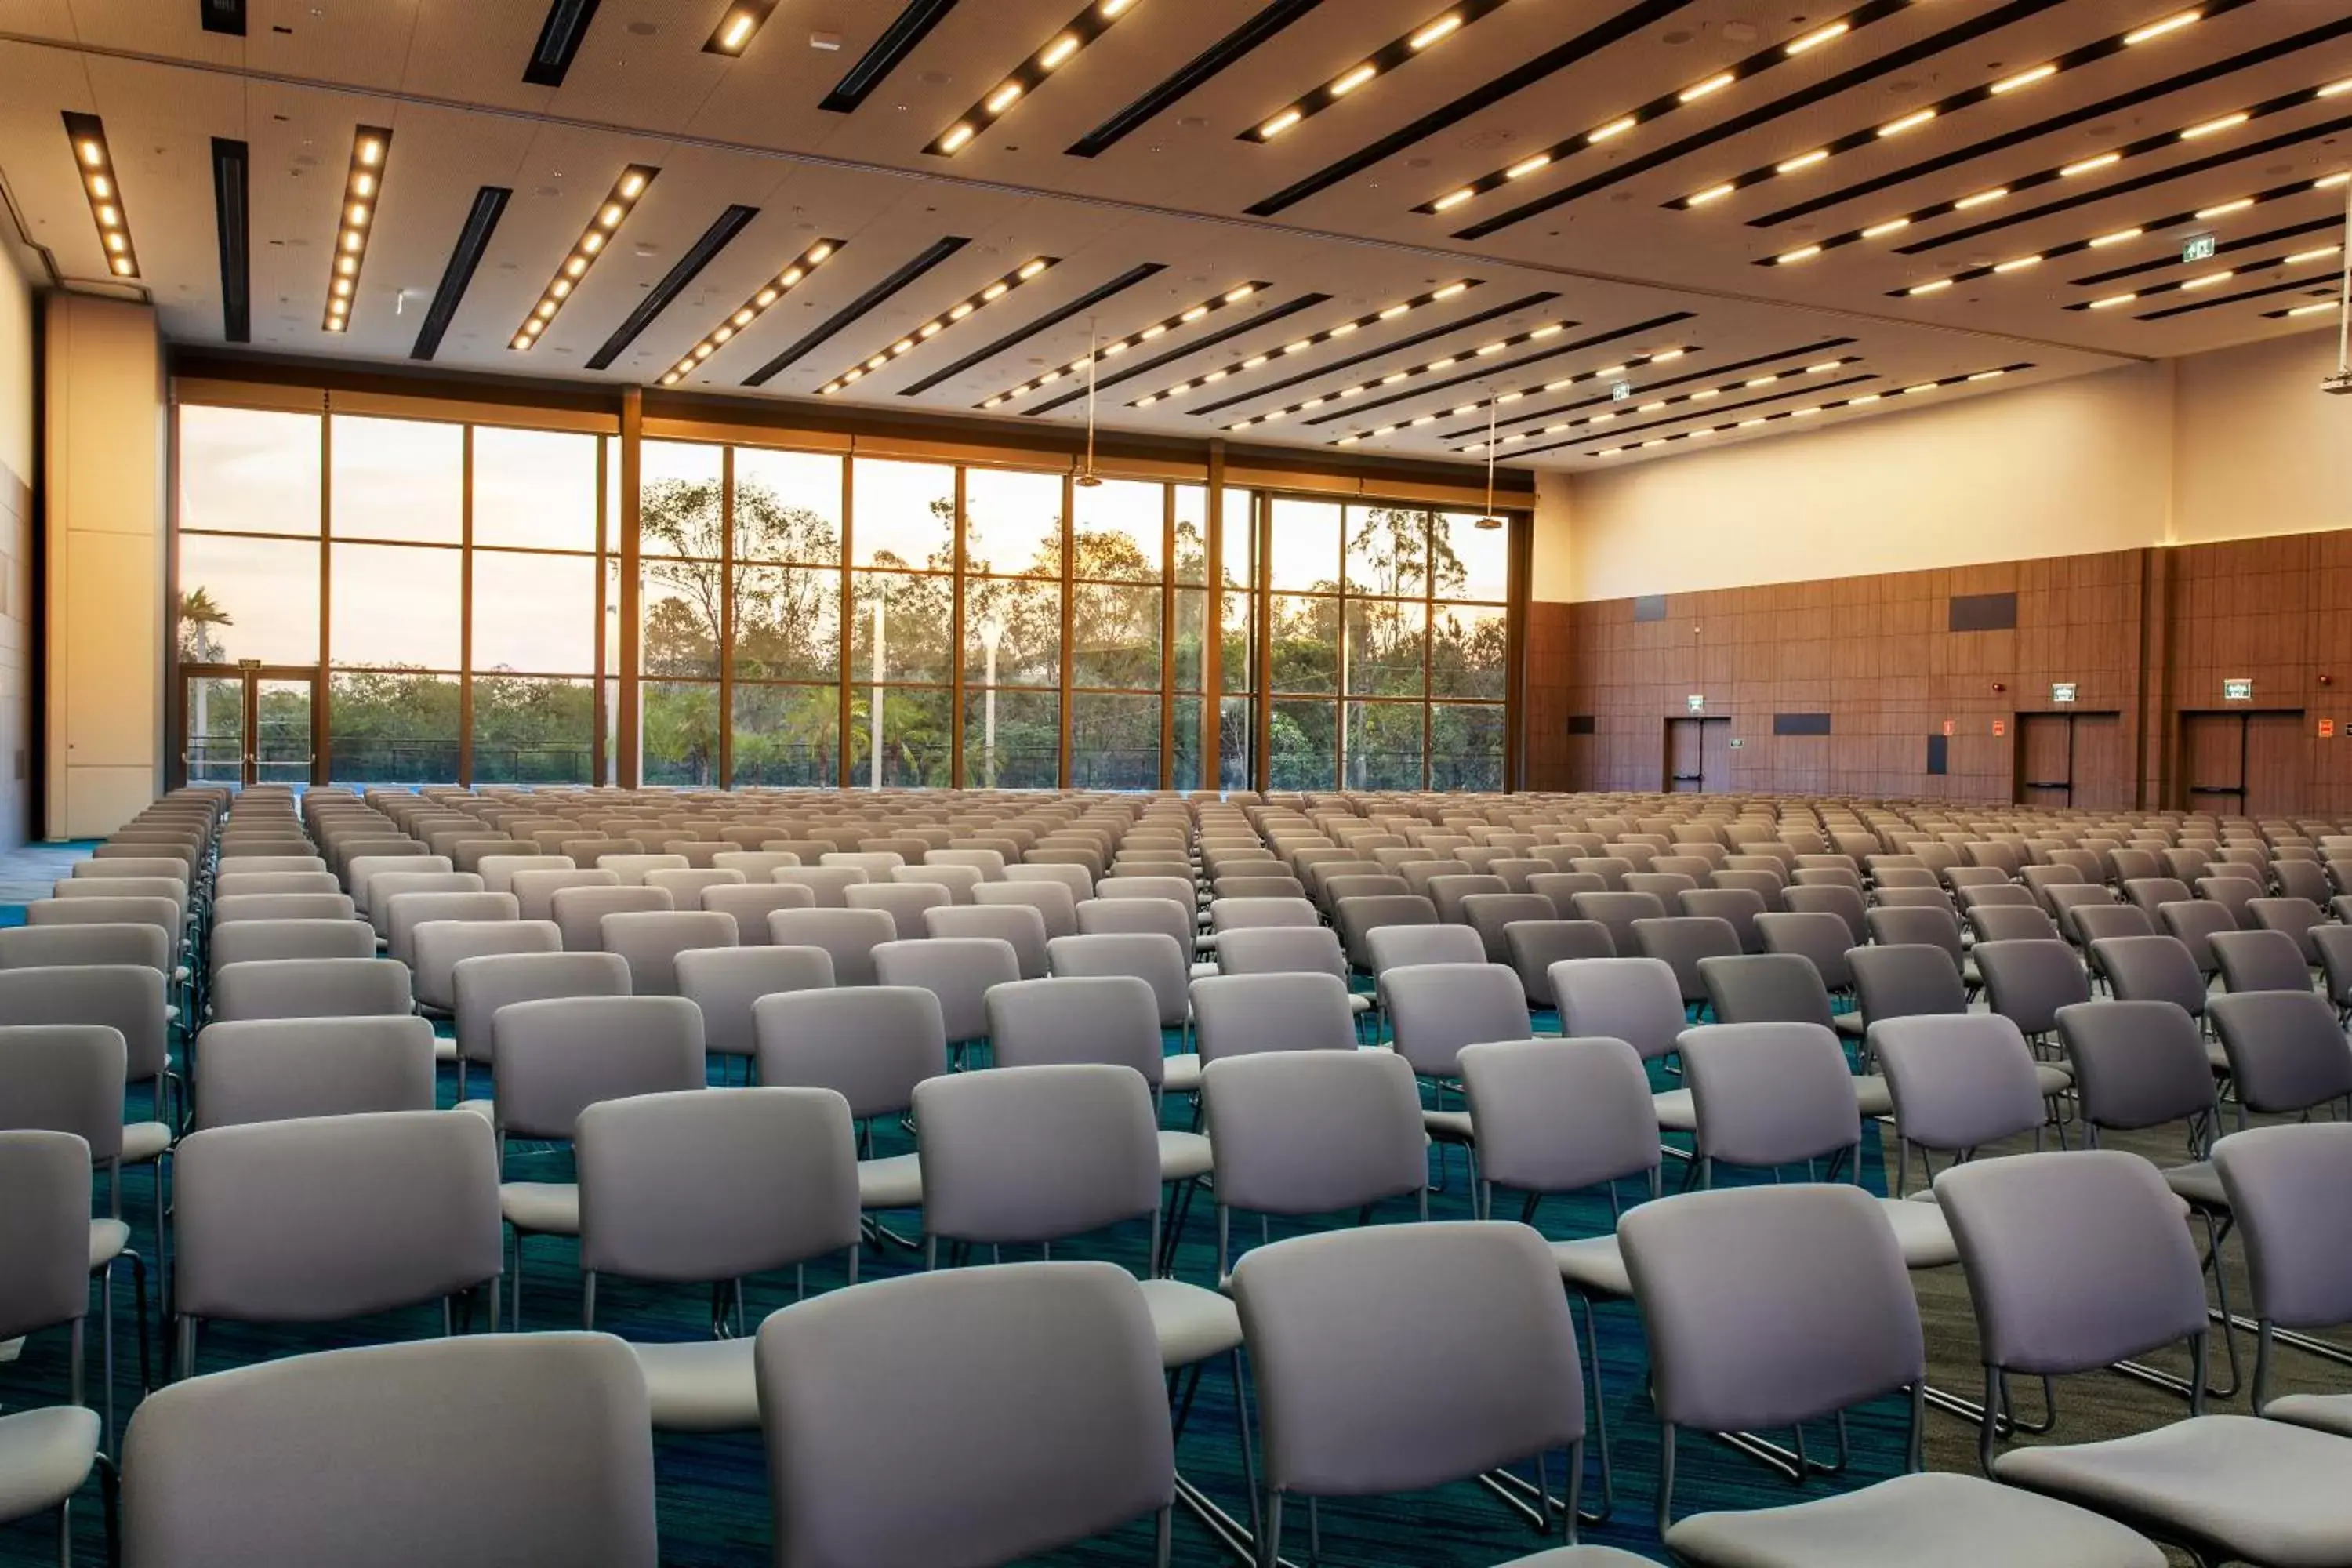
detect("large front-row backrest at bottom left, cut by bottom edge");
top-left (122, 1335), bottom-right (659, 1568)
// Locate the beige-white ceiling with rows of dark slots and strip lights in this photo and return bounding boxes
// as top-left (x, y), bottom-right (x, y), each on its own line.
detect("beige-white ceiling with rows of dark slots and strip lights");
top-left (0, 0), bottom-right (2352, 468)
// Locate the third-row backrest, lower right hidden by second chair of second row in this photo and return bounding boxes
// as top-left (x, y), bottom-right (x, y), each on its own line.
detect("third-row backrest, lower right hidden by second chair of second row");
top-left (489, 1006), bottom-right (708, 1138)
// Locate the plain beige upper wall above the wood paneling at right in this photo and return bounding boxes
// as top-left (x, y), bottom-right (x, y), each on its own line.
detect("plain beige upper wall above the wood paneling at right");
top-left (1534, 332), bottom-right (2352, 602)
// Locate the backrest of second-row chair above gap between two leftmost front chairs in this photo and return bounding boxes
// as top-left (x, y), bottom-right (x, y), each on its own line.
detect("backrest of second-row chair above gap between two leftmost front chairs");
top-left (574, 1086), bottom-right (858, 1283)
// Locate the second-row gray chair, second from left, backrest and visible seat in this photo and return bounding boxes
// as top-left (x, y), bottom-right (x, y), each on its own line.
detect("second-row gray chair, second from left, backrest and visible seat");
top-left (574, 1088), bottom-right (861, 1432)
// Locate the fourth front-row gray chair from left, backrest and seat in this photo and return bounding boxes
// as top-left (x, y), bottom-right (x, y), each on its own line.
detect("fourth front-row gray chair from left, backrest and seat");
top-left (1621, 1189), bottom-right (2164, 1568)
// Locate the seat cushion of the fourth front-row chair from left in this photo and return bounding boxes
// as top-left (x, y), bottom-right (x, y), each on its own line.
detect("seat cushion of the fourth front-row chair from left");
top-left (1665, 1474), bottom-right (2164, 1568)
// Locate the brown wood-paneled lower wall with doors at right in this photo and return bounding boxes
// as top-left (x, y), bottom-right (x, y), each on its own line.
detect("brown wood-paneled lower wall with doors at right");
top-left (1524, 534), bottom-right (2352, 815)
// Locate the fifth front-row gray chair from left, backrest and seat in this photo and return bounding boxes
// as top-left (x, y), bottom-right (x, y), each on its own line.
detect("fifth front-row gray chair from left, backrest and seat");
top-left (1936, 1149), bottom-right (2352, 1563)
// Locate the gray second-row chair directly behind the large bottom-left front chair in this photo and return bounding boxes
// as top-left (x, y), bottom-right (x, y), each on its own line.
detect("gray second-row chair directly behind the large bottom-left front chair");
top-left (172, 1109), bottom-right (503, 1373)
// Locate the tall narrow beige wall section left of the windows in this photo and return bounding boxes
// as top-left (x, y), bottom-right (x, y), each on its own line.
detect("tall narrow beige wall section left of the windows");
top-left (42, 294), bottom-right (165, 839)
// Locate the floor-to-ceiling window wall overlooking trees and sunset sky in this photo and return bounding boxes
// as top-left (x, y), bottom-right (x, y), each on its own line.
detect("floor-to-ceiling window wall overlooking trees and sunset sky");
top-left (174, 405), bottom-right (1510, 789)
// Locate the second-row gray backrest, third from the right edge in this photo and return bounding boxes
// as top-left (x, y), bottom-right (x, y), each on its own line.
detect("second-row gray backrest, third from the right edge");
top-left (1870, 1008), bottom-right (2049, 1152)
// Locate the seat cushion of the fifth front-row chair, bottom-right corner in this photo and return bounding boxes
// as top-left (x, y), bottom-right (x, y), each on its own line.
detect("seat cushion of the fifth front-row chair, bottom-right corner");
top-left (1992, 1415), bottom-right (2352, 1568)
